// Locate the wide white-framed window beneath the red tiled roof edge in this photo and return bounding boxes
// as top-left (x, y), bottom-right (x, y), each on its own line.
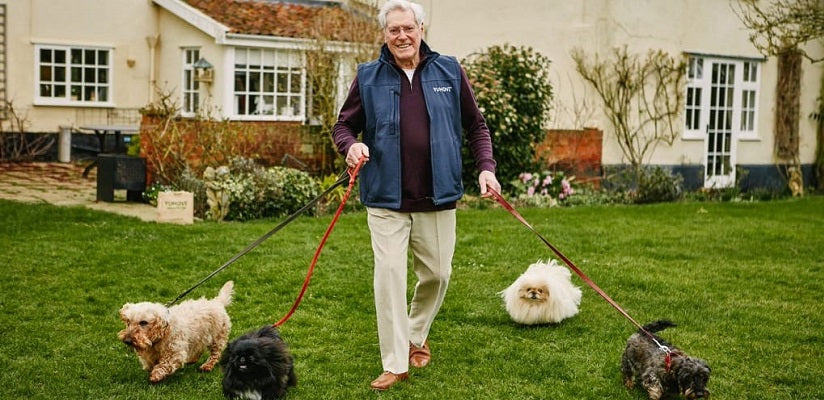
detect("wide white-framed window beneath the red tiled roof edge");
top-left (230, 47), bottom-right (306, 122)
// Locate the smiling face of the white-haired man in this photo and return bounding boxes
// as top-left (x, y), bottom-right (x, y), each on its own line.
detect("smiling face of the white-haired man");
top-left (383, 10), bottom-right (423, 68)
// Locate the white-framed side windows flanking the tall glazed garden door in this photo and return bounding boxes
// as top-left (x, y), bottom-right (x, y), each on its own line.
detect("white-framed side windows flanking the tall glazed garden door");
top-left (682, 54), bottom-right (763, 140)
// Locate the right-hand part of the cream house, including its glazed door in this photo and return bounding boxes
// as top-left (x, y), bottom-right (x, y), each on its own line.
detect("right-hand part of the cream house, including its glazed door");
top-left (421, 0), bottom-right (824, 188)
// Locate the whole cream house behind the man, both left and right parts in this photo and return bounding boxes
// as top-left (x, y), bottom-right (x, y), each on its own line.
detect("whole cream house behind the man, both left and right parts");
top-left (0, 0), bottom-right (824, 191)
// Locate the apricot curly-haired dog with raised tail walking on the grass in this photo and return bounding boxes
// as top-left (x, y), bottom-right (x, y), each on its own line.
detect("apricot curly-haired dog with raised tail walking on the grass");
top-left (117, 281), bottom-right (234, 383)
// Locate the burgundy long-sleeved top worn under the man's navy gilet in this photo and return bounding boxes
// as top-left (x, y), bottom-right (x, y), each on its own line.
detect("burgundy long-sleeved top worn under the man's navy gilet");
top-left (332, 46), bottom-right (495, 212)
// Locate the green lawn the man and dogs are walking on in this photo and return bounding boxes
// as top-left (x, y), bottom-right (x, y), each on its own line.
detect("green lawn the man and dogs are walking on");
top-left (0, 196), bottom-right (824, 400)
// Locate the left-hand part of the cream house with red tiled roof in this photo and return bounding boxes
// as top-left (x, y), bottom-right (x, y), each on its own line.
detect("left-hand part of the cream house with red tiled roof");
top-left (0, 0), bottom-right (373, 162)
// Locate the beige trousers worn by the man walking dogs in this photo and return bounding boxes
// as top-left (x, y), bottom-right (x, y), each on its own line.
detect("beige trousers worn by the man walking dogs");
top-left (367, 208), bottom-right (455, 374)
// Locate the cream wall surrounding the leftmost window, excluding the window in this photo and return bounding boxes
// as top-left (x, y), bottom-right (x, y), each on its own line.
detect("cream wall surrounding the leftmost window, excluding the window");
top-left (5, 0), bottom-right (156, 132)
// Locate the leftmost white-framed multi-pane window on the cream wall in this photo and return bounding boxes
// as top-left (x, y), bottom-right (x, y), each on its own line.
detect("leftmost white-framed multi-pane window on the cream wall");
top-left (34, 44), bottom-right (114, 107)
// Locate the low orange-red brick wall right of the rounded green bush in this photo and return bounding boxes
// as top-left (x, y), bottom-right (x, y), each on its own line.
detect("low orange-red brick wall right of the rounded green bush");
top-left (536, 128), bottom-right (604, 186)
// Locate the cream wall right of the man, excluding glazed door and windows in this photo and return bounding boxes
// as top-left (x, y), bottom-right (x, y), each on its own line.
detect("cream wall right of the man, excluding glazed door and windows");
top-left (421, 0), bottom-right (822, 164)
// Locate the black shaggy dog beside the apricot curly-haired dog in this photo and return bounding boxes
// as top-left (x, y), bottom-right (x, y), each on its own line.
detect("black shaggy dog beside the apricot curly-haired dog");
top-left (220, 326), bottom-right (298, 400)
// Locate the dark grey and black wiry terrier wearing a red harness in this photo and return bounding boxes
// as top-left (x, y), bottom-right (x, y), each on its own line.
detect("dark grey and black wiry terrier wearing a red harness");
top-left (621, 320), bottom-right (710, 400)
